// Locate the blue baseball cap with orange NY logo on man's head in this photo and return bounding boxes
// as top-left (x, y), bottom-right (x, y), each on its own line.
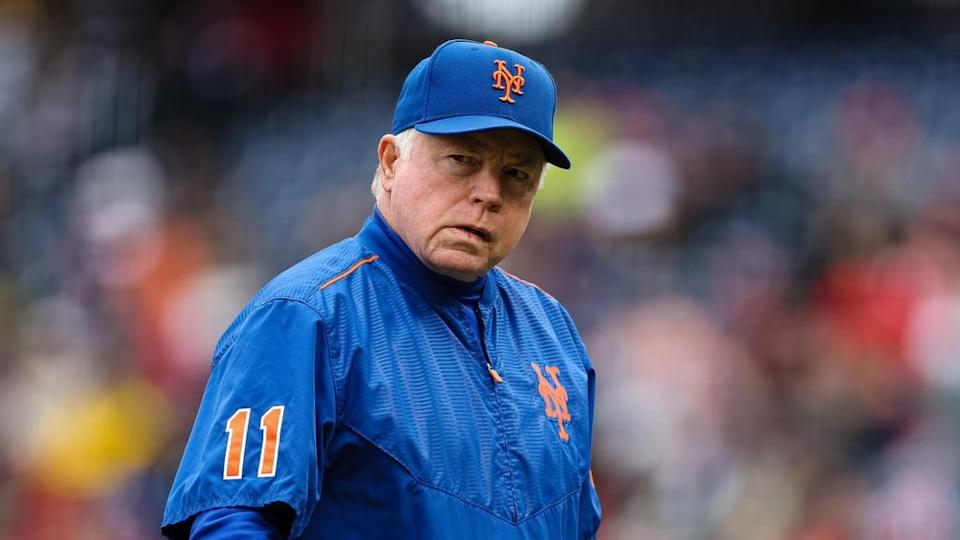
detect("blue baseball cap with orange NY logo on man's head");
top-left (393, 39), bottom-right (570, 169)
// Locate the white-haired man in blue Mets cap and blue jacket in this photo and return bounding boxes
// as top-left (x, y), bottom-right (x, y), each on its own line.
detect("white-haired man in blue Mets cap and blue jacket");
top-left (163, 40), bottom-right (600, 538)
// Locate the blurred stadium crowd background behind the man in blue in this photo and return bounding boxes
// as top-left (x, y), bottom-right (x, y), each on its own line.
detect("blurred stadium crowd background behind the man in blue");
top-left (0, 0), bottom-right (960, 540)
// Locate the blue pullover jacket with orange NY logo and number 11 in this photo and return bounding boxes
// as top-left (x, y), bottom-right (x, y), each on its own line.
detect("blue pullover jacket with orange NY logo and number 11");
top-left (163, 212), bottom-right (600, 539)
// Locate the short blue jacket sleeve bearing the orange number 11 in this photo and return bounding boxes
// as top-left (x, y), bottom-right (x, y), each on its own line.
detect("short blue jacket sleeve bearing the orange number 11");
top-left (162, 299), bottom-right (336, 538)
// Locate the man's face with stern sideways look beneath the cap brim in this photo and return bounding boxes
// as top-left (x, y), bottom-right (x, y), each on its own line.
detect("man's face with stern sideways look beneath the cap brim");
top-left (378, 129), bottom-right (544, 281)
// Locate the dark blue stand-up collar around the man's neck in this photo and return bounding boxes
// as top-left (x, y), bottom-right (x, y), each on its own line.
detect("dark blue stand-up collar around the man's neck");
top-left (357, 205), bottom-right (495, 311)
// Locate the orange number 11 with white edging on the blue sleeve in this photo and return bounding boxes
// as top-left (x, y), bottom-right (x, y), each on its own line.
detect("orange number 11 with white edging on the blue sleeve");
top-left (223, 405), bottom-right (283, 480)
